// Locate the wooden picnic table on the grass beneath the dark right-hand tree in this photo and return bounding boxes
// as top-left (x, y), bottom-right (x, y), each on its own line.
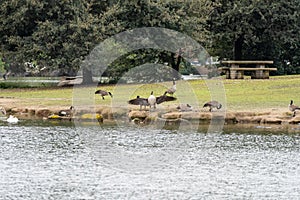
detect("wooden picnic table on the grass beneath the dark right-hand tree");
top-left (219, 60), bottom-right (277, 79)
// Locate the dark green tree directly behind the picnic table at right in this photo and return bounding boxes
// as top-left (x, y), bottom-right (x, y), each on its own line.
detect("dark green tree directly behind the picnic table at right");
top-left (208, 0), bottom-right (300, 73)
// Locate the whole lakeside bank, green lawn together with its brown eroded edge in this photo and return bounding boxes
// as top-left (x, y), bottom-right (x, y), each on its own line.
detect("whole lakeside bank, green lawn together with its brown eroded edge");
top-left (0, 75), bottom-right (300, 124)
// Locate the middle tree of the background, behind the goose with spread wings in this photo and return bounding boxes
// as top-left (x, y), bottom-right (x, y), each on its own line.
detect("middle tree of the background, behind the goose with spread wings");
top-left (102, 0), bottom-right (213, 80)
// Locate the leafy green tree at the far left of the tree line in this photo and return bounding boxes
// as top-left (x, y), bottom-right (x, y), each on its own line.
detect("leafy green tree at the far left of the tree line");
top-left (0, 0), bottom-right (106, 79)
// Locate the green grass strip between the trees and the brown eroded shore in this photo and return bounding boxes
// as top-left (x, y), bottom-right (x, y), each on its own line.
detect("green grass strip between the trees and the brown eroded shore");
top-left (0, 75), bottom-right (300, 111)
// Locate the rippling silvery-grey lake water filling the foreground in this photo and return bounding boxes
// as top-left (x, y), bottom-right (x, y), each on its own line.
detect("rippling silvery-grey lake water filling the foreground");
top-left (0, 119), bottom-right (300, 199)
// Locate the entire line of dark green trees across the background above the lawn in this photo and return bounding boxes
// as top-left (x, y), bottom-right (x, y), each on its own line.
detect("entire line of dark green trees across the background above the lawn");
top-left (0, 0), bottom-right (300, 81)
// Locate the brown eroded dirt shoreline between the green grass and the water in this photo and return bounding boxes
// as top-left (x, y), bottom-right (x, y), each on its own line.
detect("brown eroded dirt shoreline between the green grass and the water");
top-left (5, 106), bottom-right (300, 125)
